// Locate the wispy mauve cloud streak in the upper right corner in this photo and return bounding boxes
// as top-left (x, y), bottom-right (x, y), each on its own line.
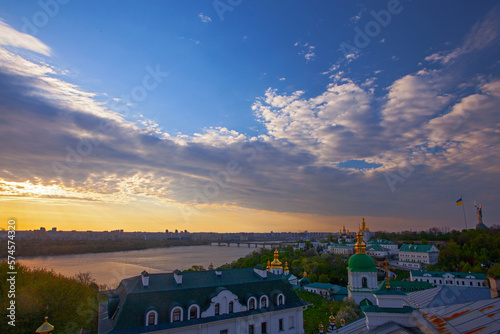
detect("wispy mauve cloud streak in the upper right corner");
top-left (425, 7), bottom-right (500, 65)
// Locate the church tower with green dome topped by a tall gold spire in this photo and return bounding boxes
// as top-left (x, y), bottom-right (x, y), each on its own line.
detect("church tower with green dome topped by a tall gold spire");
top-left (347, 229), bottom-right (378, 304)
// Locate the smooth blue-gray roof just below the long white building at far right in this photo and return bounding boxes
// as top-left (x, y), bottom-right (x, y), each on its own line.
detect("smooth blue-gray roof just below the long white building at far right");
top-left (406, 285), bottom-right (491, 308)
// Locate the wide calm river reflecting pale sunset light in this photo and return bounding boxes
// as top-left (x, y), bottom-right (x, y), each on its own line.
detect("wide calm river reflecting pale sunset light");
top-left (19, 246), bottom-right (256, 288)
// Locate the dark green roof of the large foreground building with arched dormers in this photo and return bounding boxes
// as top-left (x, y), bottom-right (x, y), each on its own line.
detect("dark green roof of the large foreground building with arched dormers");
top-left (105, 268), bottom-right (303, 333)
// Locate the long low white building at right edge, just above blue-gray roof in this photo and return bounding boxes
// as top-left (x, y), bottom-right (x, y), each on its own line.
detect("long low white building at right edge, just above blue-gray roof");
top-left (410, 270), bottom-right (488, 287)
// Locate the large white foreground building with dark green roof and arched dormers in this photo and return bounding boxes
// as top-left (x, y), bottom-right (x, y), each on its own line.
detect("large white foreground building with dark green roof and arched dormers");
top-left (98, 266), bottom-right (307, 334)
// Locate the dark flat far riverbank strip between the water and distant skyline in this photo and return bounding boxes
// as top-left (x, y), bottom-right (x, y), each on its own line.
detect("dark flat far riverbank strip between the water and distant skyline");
top-left (0, 239), bottom-right (208, 258)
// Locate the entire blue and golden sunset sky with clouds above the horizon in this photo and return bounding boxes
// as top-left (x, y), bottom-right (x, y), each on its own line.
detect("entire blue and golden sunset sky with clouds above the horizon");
top-left (0, 0), bottom-right (500, 232)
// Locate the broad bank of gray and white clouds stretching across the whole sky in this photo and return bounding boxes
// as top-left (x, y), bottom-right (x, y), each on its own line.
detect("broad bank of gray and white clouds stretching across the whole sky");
top-left (0, 21), bottom-right (500, 228)
